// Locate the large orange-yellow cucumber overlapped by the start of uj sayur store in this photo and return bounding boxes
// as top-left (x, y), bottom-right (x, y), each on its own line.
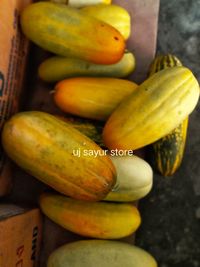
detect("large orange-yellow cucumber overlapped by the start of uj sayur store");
top-left (2, 111), bottom-right (116, 201)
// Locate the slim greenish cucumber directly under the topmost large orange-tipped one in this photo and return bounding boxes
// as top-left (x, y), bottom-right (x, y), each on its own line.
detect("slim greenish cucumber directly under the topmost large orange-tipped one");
top-left (38, 52), bottom-right (135, 82)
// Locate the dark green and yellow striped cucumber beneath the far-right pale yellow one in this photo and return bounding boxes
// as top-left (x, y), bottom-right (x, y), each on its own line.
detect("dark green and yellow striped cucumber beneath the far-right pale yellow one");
top-left (148, 54), bottom-right (188, 176)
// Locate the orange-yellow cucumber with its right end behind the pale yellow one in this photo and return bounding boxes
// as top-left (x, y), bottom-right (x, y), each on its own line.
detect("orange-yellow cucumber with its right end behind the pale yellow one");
top-left (54, 77), bottom-right (138, 120)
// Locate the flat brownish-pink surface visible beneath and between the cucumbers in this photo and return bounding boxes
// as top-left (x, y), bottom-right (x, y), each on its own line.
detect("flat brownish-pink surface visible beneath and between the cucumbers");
top-left (2, 0), bottom-right (159, 267)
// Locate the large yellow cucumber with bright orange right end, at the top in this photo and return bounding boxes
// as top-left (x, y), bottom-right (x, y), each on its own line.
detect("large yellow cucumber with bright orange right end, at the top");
top-left (21, 2), bottom-right (125, 64)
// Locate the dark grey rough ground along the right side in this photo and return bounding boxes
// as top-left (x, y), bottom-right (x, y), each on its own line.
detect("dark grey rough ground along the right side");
top-left (136, 0), bottom-right (200, 267)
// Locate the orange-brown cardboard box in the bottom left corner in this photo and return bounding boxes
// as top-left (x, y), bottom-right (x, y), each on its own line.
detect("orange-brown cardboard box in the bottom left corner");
top-left (0, 204), bottom-right (42, 267)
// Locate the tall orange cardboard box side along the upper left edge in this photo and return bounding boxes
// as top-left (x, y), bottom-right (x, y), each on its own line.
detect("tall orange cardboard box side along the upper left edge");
top-left (0, 0), bottom-right (31, 196)
